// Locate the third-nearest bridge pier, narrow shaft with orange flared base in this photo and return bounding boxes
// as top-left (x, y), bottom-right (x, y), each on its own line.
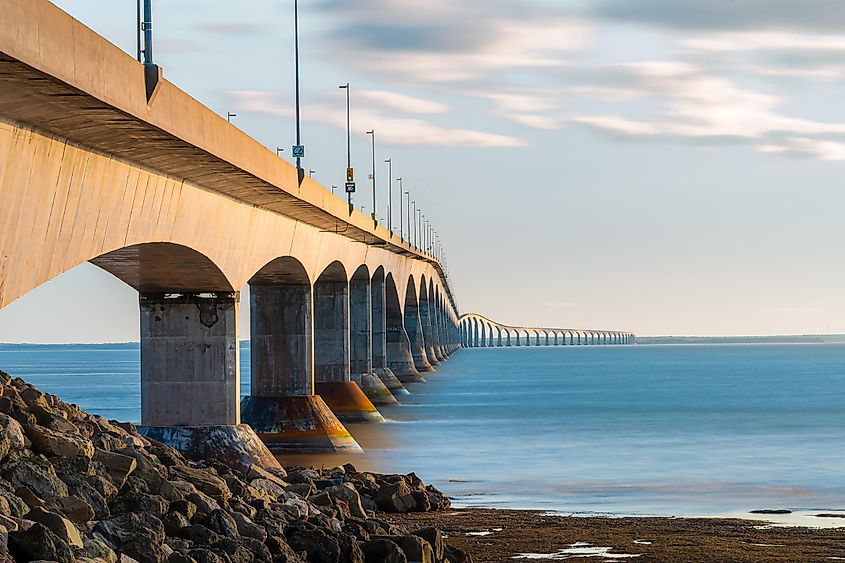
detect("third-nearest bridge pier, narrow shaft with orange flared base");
top-left (314, 274), bottom-right (384, 422)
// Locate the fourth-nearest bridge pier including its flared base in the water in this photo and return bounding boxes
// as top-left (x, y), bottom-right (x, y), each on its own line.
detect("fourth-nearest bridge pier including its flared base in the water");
top-left (349, 266), bottom-right (399, 405)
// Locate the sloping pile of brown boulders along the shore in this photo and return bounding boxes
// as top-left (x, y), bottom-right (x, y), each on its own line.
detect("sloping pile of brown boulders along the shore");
top-left (0, 371), bottom-right (470, 563)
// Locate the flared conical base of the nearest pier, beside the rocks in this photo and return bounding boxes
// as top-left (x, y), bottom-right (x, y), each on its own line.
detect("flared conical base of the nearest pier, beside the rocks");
top-left (138, 424), bottom-right (281, 473)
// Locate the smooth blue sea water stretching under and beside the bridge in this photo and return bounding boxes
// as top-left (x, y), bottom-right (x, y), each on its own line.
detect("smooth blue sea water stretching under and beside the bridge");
top-left (0, 344), bottom-right (845, 515)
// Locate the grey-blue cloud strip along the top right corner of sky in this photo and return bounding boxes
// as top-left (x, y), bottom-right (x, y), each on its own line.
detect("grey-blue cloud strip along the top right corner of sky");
top-left (590, 0), bottom-right (845, 33)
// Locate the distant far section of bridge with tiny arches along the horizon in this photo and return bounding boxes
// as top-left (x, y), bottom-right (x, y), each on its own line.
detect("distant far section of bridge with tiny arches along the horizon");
top-left (458, 313), bottom-right (637, 348)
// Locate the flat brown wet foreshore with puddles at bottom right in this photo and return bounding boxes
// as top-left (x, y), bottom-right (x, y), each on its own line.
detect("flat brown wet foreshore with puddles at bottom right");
top-left (387, 509), bottom-right (845, 563)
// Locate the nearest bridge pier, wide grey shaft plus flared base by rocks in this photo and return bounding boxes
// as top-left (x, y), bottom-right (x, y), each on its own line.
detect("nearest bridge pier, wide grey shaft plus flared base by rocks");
top-left (139, 292), bottom-right (279, 469)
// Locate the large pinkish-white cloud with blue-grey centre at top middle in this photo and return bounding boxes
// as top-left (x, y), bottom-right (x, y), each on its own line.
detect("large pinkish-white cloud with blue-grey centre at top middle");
top-left (317, 0), bottom-right (592, 82)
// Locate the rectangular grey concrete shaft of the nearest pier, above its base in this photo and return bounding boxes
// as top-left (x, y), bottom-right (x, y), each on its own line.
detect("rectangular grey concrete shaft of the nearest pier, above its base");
top-left (140, 293), bottom-right (240, 426)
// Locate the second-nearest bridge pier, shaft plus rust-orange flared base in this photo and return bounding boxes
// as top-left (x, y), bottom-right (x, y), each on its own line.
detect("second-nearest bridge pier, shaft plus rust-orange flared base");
top-left (241, 279), bottom-right (361, 451)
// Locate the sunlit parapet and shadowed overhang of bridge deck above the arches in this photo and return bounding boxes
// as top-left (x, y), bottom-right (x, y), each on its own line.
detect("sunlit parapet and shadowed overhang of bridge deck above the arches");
top-left (0, 0), bottom-right (451, 297)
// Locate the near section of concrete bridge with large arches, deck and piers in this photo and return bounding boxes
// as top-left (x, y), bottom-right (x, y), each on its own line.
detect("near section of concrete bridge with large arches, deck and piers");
top-left (0, 0), bottom-right (460, 470)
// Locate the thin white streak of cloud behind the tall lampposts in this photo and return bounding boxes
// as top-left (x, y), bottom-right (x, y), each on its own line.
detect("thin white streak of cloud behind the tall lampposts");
top-left (226, 90), bottom-right (526, 148)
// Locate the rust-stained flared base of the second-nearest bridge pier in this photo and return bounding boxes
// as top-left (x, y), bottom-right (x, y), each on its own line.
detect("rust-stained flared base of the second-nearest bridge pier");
top-left (241, 395), bottom-right (362, 453)
